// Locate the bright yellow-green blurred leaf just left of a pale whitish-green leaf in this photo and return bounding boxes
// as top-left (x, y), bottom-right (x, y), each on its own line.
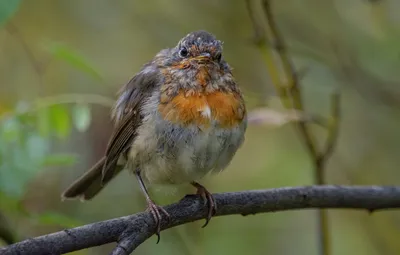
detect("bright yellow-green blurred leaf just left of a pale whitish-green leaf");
top-left (50, 105), bottom-right (71, 138)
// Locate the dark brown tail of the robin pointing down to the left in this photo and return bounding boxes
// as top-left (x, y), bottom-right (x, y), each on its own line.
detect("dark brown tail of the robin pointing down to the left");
top-left (61, 157), bottom-right (122, 200)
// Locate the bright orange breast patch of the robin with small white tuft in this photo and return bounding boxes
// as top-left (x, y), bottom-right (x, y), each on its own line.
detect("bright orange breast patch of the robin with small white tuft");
top-left (159, 91), bottom-right (245, 128)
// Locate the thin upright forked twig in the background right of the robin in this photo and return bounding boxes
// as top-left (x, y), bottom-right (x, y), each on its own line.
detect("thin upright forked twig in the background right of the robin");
top-left (247, 0), bottom-right (340, 255)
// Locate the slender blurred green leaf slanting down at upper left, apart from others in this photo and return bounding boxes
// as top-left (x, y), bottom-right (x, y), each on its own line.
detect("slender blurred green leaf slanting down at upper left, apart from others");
top-left (45, 44), bottom-right (102, 80)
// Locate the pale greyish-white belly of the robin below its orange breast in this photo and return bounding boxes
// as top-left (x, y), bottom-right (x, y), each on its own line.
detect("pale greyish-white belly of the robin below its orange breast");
top-left (130, 110), bottom-right (246, 184)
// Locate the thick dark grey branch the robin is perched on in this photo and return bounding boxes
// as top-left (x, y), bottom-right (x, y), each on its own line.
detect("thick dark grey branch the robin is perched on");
top-left (0, 185), bottom-right (400, 255)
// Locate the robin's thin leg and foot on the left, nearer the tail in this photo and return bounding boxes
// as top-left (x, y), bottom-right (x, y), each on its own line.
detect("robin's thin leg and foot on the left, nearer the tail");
top-left (135, 169), bottom-right (170, 243)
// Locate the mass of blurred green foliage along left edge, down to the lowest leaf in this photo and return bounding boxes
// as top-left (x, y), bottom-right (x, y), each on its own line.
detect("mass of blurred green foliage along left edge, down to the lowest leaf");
top-left (0, 93), bottom-right (91, 237)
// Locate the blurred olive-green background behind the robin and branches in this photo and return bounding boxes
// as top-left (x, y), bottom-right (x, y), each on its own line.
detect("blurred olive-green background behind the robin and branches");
top-left (0, 0), bottom-right (400, 255)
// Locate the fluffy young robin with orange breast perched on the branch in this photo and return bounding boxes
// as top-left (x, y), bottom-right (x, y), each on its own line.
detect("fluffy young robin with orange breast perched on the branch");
top-left (62, 31), bottom-right (247, 239)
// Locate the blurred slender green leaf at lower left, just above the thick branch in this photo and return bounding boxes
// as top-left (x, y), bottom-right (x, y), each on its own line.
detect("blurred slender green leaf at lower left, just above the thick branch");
top-left (31, 212), bottom-right (82, 228)
